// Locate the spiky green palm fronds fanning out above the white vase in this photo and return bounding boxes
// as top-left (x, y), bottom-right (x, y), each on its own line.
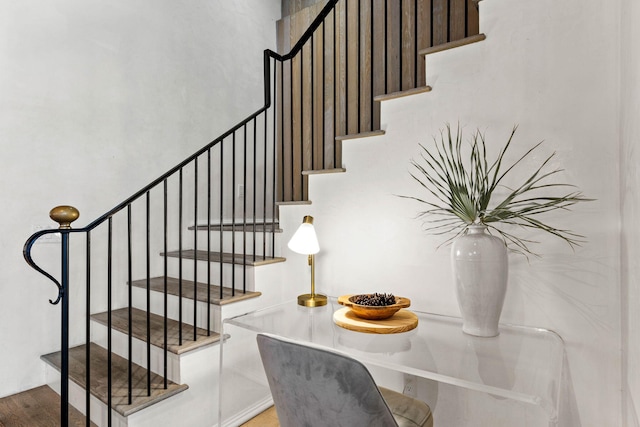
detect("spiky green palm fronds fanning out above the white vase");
top-left (402, 124), bottom-right (590, 256)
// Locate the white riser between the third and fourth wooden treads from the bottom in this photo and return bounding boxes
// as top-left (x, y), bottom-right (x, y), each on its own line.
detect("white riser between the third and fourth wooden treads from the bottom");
top-left (162, 258), bottom-right (255, 291)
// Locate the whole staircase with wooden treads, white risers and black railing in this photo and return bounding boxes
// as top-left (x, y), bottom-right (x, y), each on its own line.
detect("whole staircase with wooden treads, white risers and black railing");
top-left (24, 0), bottom-right (483, 427)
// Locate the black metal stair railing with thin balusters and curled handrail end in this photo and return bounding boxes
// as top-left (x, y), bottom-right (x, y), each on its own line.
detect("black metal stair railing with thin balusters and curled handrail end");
top-left (24, 0), bottom-right (475, 426)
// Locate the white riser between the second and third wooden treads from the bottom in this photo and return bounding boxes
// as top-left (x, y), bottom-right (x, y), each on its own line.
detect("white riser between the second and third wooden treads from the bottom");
top-left (131, 287), bottom-right (220, 332)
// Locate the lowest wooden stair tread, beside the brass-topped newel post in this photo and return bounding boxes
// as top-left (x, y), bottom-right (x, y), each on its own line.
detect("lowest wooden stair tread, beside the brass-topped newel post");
top-left (41, 343), bottom-right (189, 417)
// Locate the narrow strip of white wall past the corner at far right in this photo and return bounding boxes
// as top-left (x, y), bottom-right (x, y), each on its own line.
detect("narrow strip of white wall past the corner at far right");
top-left (620, 0), bottom-right (640, 427)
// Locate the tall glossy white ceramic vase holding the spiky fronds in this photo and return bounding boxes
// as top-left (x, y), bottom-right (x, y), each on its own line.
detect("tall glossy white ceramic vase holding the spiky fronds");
top-left (451, 225), bottom-right (509, 337)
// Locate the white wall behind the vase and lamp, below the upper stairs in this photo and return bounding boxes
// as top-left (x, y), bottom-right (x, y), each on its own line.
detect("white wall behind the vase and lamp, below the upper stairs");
top-left (281, 0), bottom-right (620, 426)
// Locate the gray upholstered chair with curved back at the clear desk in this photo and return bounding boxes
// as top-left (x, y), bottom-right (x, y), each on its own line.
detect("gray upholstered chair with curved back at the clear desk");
top-left (257, 334), bottom-right (433, 427)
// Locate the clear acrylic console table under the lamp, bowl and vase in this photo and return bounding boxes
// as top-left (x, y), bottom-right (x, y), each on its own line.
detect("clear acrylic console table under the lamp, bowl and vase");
top-left (219, 298), bottom-right (564, 427)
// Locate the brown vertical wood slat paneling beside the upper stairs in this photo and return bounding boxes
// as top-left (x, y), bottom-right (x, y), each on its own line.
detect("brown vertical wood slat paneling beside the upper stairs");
top-left (278, 0), bottom-right (479, 201)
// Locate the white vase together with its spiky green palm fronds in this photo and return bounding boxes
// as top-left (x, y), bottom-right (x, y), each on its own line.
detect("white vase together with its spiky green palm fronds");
top-left (403, 125), bottom-right (589, 336)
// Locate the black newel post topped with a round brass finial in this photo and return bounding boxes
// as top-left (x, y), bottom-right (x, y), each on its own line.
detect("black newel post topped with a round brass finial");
top-left (49, 206), bottom-right (80, 427)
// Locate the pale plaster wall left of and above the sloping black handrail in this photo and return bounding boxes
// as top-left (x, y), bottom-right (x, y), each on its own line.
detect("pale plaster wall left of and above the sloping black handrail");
top-left (0, 0), bottom-right (280, 396)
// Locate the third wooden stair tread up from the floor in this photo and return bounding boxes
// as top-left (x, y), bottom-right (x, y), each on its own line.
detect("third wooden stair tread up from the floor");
top-left (132, 277), bottom-right (262, 305)
